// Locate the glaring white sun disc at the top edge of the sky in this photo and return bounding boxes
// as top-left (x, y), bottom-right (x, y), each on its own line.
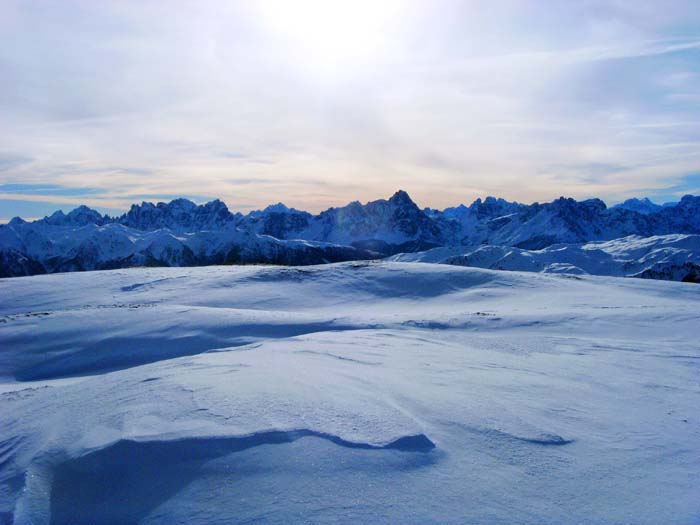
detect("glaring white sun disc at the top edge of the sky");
top-left (259, 0), bottom-right (401, 74)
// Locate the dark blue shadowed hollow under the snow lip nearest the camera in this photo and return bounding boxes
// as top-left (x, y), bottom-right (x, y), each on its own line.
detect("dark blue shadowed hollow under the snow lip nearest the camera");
top-left (46, 429), bottom-right (435, 525)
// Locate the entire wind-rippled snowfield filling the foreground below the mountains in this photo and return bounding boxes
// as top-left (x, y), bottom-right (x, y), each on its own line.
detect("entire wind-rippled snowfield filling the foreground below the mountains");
top-left (0, 262), bottom-right (700, 525)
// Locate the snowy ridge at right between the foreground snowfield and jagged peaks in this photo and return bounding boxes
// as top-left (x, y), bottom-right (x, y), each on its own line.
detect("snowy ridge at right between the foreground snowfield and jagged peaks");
top-left (389, 235), bottom-right (700, 282)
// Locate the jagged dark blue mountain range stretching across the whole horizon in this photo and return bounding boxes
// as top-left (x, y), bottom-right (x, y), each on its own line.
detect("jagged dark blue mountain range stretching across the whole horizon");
top-left (0, 190), bottom-right (700, 280)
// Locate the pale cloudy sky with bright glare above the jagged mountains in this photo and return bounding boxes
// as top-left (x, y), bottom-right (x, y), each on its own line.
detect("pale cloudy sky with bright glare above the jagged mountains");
top-left (0, 0), bottom-right (700, 220)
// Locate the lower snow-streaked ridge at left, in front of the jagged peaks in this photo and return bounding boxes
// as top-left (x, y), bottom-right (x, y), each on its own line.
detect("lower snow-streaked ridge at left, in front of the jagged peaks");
top-left (0, 222), bottom-right (378, 277)
